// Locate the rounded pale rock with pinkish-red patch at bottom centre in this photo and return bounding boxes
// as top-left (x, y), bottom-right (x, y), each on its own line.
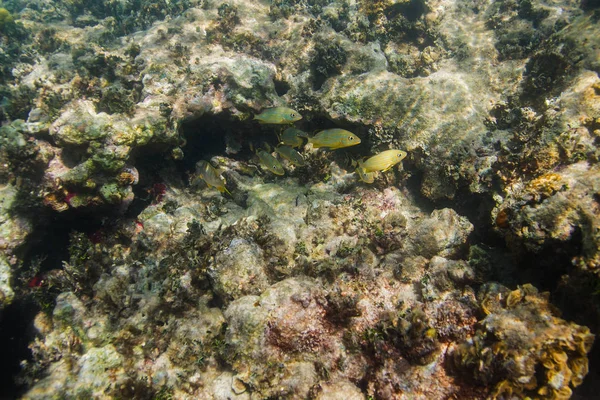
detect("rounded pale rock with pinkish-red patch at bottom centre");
top-left (225, 278), bottom-right (333, 397)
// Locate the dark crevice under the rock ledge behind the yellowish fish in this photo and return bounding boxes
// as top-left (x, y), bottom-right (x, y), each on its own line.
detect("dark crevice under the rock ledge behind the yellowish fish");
top-left (125, 113), bottom-right (380, 218)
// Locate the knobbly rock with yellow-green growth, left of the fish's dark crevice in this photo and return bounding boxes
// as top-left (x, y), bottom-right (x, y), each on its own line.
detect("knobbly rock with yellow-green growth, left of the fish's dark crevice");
top-left (44, 101), bottom-right (170, 210)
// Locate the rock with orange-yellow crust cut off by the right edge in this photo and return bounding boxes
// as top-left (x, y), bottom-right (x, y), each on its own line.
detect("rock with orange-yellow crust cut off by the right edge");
top-left (493, 161), bottom-right (600, 272)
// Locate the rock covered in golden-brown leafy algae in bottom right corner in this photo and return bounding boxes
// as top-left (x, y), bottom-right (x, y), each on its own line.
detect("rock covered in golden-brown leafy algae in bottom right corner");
top-left (451, 284), bottom-right (594, 399)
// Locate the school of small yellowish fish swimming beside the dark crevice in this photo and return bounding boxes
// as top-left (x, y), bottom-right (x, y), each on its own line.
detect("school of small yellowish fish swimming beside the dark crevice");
top-left (196, 107), bottom-right (407, 195)
